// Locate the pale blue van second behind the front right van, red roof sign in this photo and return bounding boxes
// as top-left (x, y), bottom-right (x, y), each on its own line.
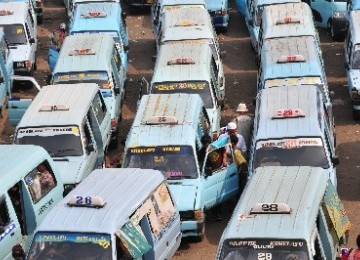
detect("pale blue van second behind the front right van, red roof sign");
top-left (258, 36), bottom-right (331, 110)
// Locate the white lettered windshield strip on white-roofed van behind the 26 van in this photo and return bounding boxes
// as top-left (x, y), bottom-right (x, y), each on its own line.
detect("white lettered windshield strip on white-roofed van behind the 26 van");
top-left (17, 126), bottom-right (80, 138)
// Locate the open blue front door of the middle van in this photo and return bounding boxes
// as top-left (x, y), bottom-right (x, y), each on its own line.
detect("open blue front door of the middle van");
top-left (202, 139), bottom-right (239, 208)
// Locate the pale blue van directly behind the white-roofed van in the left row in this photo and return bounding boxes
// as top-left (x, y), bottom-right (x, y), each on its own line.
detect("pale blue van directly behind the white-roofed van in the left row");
top-left (52, 34), bottom-right (126, 141)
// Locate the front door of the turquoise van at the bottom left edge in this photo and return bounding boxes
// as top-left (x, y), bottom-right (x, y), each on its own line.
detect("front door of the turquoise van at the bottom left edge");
top-left (0, 194), bottom-right (22, 259)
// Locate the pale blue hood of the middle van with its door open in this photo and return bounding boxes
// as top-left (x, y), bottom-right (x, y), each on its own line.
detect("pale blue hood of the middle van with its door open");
top-left (169, 182), bottom-right (199, 211)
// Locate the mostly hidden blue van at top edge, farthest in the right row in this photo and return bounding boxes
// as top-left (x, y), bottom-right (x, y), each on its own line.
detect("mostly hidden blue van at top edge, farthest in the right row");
top-left (243, 0), bottom-right (301, 52)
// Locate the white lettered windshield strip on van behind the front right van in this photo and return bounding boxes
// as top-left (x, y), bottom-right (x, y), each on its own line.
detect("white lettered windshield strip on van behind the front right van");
top-left (256, 138), bottom-right (322, 150)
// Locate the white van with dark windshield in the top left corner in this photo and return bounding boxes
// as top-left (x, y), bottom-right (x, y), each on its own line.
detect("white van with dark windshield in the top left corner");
top-left (0, 2), bottom-right (38, 76)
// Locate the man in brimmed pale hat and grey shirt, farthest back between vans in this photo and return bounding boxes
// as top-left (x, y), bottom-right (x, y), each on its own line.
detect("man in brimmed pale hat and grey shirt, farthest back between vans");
top-left (234, 103), bottom-right (253, 147)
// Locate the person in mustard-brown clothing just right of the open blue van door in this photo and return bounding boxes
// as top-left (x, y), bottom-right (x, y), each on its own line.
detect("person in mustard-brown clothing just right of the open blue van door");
top-left (230, 135), bottom-right (248, 197)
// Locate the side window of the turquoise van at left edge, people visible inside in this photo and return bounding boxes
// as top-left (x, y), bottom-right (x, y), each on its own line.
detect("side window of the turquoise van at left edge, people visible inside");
top-left (25, 161), bottom-right (56, 203)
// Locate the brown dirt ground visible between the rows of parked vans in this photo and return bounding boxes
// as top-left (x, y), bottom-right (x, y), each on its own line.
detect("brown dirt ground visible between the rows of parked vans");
top-left (0, 0), bottom-right (360, 259)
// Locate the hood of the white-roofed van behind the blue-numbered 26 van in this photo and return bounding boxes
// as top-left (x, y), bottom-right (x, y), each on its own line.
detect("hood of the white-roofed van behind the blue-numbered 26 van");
top-left (54, 158), bottom-right (86, 185)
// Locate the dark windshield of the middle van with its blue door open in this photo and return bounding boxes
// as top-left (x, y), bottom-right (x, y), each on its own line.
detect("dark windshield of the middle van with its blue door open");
top-left (123, 145), bottom-right (198, 179)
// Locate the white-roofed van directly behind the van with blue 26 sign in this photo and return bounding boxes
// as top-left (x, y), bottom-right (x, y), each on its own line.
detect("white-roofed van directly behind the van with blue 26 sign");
top-left (14, 83), bottom-right (111, 192)
